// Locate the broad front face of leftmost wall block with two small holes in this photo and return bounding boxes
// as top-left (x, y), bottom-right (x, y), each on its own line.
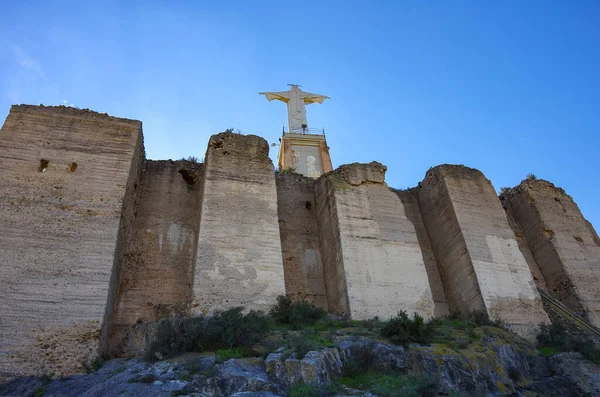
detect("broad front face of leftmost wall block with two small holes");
top-left (0, 106), bottom-right (143, 375)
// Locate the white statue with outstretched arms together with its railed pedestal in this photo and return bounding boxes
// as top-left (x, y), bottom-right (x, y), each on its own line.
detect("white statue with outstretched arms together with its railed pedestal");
top-left (260, 84), bottom-right (333, 178)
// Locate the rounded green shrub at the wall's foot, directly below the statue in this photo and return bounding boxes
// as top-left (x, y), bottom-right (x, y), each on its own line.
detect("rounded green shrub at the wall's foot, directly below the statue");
top-left (269, 295), bottom-right (327, 329)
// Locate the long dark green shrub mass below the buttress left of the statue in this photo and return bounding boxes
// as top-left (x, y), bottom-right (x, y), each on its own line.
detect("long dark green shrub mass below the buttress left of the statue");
top-left (146, 307), bottom-right (273, 361)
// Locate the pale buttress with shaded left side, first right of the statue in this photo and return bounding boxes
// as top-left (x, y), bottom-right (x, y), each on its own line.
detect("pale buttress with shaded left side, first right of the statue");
top-left (315, 163), bottom-right (434, 319)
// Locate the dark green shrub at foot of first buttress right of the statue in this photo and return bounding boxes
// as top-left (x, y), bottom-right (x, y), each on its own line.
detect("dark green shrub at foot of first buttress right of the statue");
top-left (381, 310), bottom-right (434, 345)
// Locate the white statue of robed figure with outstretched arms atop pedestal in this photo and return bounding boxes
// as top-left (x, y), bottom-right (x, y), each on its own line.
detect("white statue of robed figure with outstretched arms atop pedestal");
top-left (259, 84), bottom-right (330, 132)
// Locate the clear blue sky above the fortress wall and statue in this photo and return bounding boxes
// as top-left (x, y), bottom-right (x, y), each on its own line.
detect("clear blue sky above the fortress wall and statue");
top-left (0, 0), bottom-right (600, 228)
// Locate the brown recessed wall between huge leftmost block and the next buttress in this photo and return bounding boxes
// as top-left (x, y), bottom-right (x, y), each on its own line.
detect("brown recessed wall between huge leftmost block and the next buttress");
top-left (110, 161), bottom-right (203, 355)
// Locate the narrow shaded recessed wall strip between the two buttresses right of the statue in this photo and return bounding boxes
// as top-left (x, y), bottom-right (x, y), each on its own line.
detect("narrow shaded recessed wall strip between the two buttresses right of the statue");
top-left (392, 188), bottom-right (450, 317)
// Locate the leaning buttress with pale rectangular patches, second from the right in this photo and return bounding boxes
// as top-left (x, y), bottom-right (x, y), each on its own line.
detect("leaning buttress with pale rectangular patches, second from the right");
top-left (418, 165), bottom-right (549, 339)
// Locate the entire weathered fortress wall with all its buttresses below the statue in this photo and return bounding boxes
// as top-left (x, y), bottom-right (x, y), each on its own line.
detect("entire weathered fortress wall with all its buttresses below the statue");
top-left (0, 106), bottom-right (600, 380)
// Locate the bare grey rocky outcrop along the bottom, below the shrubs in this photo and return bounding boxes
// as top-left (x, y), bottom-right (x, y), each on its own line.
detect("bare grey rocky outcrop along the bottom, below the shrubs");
top-left (0, 328), bottom-right (600, 397)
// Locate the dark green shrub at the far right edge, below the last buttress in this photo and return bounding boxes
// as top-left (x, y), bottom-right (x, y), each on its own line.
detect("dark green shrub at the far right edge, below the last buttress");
top-left (538, 324), bottom-right (600, 364)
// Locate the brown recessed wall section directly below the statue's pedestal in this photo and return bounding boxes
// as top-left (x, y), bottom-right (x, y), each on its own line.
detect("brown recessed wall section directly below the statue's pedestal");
top-left (276, 174), bottom-right (327, 310)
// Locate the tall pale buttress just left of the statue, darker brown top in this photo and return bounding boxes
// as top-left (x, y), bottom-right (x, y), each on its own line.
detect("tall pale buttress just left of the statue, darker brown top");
top-left (194, 133), bottom-right (285, 312)
